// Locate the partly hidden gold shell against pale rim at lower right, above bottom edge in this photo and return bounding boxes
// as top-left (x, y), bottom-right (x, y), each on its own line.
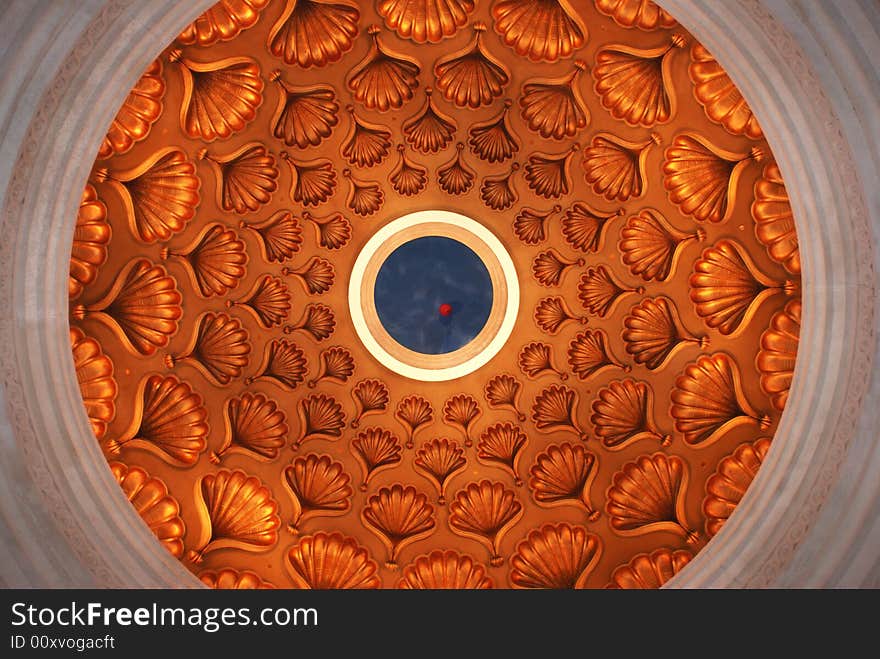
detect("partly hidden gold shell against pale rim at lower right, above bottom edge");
top-left (703, 437), bottom-right (770, 538)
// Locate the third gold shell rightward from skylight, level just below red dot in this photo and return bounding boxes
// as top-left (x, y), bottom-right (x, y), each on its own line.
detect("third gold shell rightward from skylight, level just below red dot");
top-left (622, 295), bottom-right (709, 371)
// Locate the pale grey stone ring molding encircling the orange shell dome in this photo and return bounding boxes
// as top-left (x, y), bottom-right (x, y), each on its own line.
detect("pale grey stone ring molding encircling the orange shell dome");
top-left (0, 0), bottom-right (880, 587)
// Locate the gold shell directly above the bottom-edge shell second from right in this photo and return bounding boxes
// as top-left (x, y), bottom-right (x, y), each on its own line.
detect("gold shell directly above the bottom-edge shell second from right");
top-left (529, 442), bottom-right (599, 522)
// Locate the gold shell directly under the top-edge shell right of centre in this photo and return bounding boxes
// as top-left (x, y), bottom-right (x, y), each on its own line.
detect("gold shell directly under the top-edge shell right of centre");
top-left (519, 60), bottom-right (590, 140)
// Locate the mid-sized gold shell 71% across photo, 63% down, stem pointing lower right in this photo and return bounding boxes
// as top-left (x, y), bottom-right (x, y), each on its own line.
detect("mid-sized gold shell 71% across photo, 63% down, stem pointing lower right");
top-left (590, 378), bottom-right (672, 451)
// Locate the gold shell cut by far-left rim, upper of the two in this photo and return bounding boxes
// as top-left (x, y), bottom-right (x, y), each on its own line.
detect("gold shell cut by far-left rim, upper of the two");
top-left (67, 183), bottom-right (112, 300)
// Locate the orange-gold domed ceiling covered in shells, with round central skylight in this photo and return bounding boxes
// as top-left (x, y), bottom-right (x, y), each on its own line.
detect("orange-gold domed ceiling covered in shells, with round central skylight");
top-left (70, 0), bottom-right (800, 588)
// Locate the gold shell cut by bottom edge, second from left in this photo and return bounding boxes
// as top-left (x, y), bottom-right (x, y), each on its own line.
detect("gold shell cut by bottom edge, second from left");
top-left (284, 532), bottom-right (382, 590)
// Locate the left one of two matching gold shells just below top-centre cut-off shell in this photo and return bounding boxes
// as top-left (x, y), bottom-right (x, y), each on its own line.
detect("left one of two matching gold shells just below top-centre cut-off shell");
top-left (348, 25), bottom-right (421, 112)
